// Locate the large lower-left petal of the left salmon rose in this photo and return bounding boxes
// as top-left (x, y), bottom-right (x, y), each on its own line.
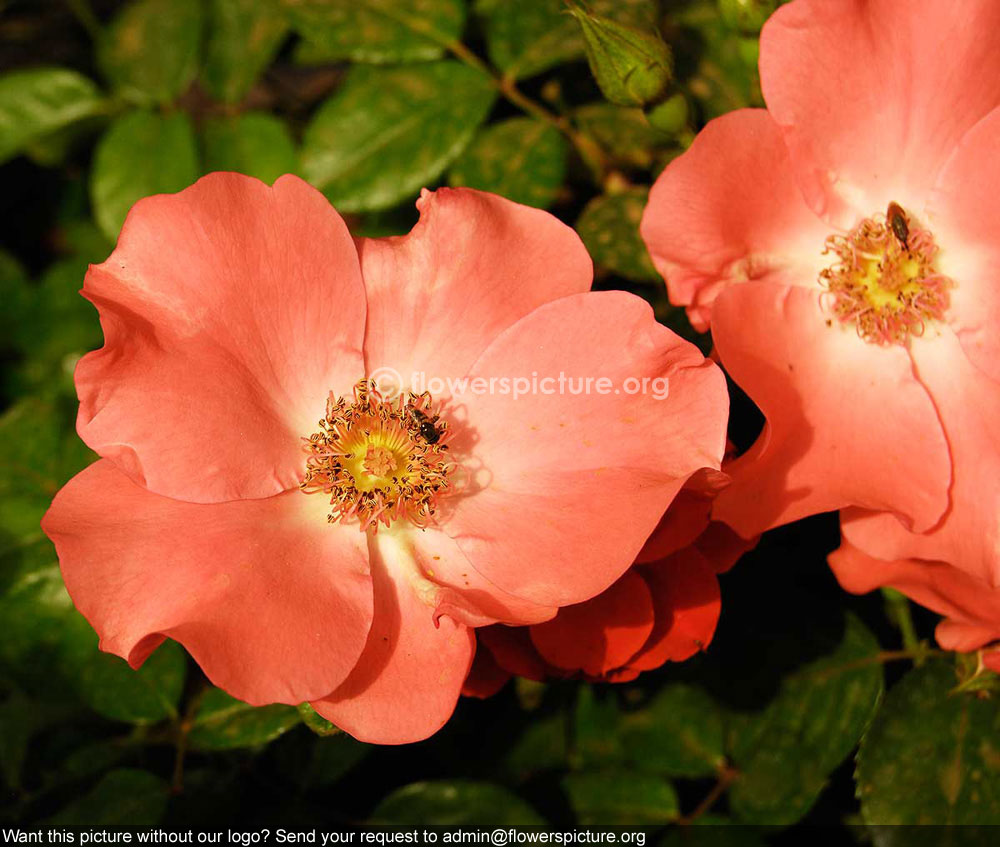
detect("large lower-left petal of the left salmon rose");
top-left (42, 460), bottom-right (372, 705)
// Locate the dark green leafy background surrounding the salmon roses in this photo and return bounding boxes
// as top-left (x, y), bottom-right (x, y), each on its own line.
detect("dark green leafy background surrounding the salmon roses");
top-left (0, 0), bottom-right (1000, 845)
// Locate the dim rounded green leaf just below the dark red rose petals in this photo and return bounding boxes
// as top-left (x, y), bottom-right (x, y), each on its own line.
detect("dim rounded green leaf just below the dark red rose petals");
top-left (622, 683), bottom-right (725, 778)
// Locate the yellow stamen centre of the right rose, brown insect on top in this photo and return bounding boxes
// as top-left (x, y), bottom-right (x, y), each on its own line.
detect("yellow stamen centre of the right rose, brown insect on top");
top-left (819, 203), bottom-right (952, 345)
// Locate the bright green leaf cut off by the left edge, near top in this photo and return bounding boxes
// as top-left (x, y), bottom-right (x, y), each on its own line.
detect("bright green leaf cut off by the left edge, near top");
top-left (0, 68), bottom-right (104, 162)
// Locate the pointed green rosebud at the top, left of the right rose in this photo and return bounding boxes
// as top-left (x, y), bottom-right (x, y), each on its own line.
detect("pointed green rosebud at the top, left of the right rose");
top-left (569, 3), bottom-right (674, 106)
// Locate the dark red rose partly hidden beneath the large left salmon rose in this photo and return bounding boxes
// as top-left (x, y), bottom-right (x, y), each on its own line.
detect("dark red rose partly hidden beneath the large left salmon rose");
top-left (463, 474), bottom-right (755, 697)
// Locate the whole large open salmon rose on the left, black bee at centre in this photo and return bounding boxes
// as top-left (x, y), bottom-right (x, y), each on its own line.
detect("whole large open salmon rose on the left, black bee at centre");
top-left (43, 173), bottom-right (727, 743)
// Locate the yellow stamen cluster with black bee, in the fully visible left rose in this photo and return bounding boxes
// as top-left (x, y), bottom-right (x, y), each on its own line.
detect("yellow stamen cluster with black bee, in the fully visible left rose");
top-left (299, 380), bottom-right (454, 531)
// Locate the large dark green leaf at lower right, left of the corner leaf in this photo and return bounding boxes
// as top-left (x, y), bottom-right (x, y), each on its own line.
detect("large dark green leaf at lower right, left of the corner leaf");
top-left (729, 615), bottom-right (882, 825)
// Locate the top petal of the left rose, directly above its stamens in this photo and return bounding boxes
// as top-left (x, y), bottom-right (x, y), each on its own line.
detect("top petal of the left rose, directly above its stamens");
top-left (358, 188), bottom-right (593, 390)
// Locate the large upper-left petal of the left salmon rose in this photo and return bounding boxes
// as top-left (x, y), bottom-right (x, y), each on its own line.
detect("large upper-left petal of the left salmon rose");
top-left (76, 173), bottom-right (365, 503)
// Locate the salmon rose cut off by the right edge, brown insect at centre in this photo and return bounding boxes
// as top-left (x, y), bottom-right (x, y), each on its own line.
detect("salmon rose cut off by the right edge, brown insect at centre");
top-left (642, 0), bottom-right (1000, 568)
